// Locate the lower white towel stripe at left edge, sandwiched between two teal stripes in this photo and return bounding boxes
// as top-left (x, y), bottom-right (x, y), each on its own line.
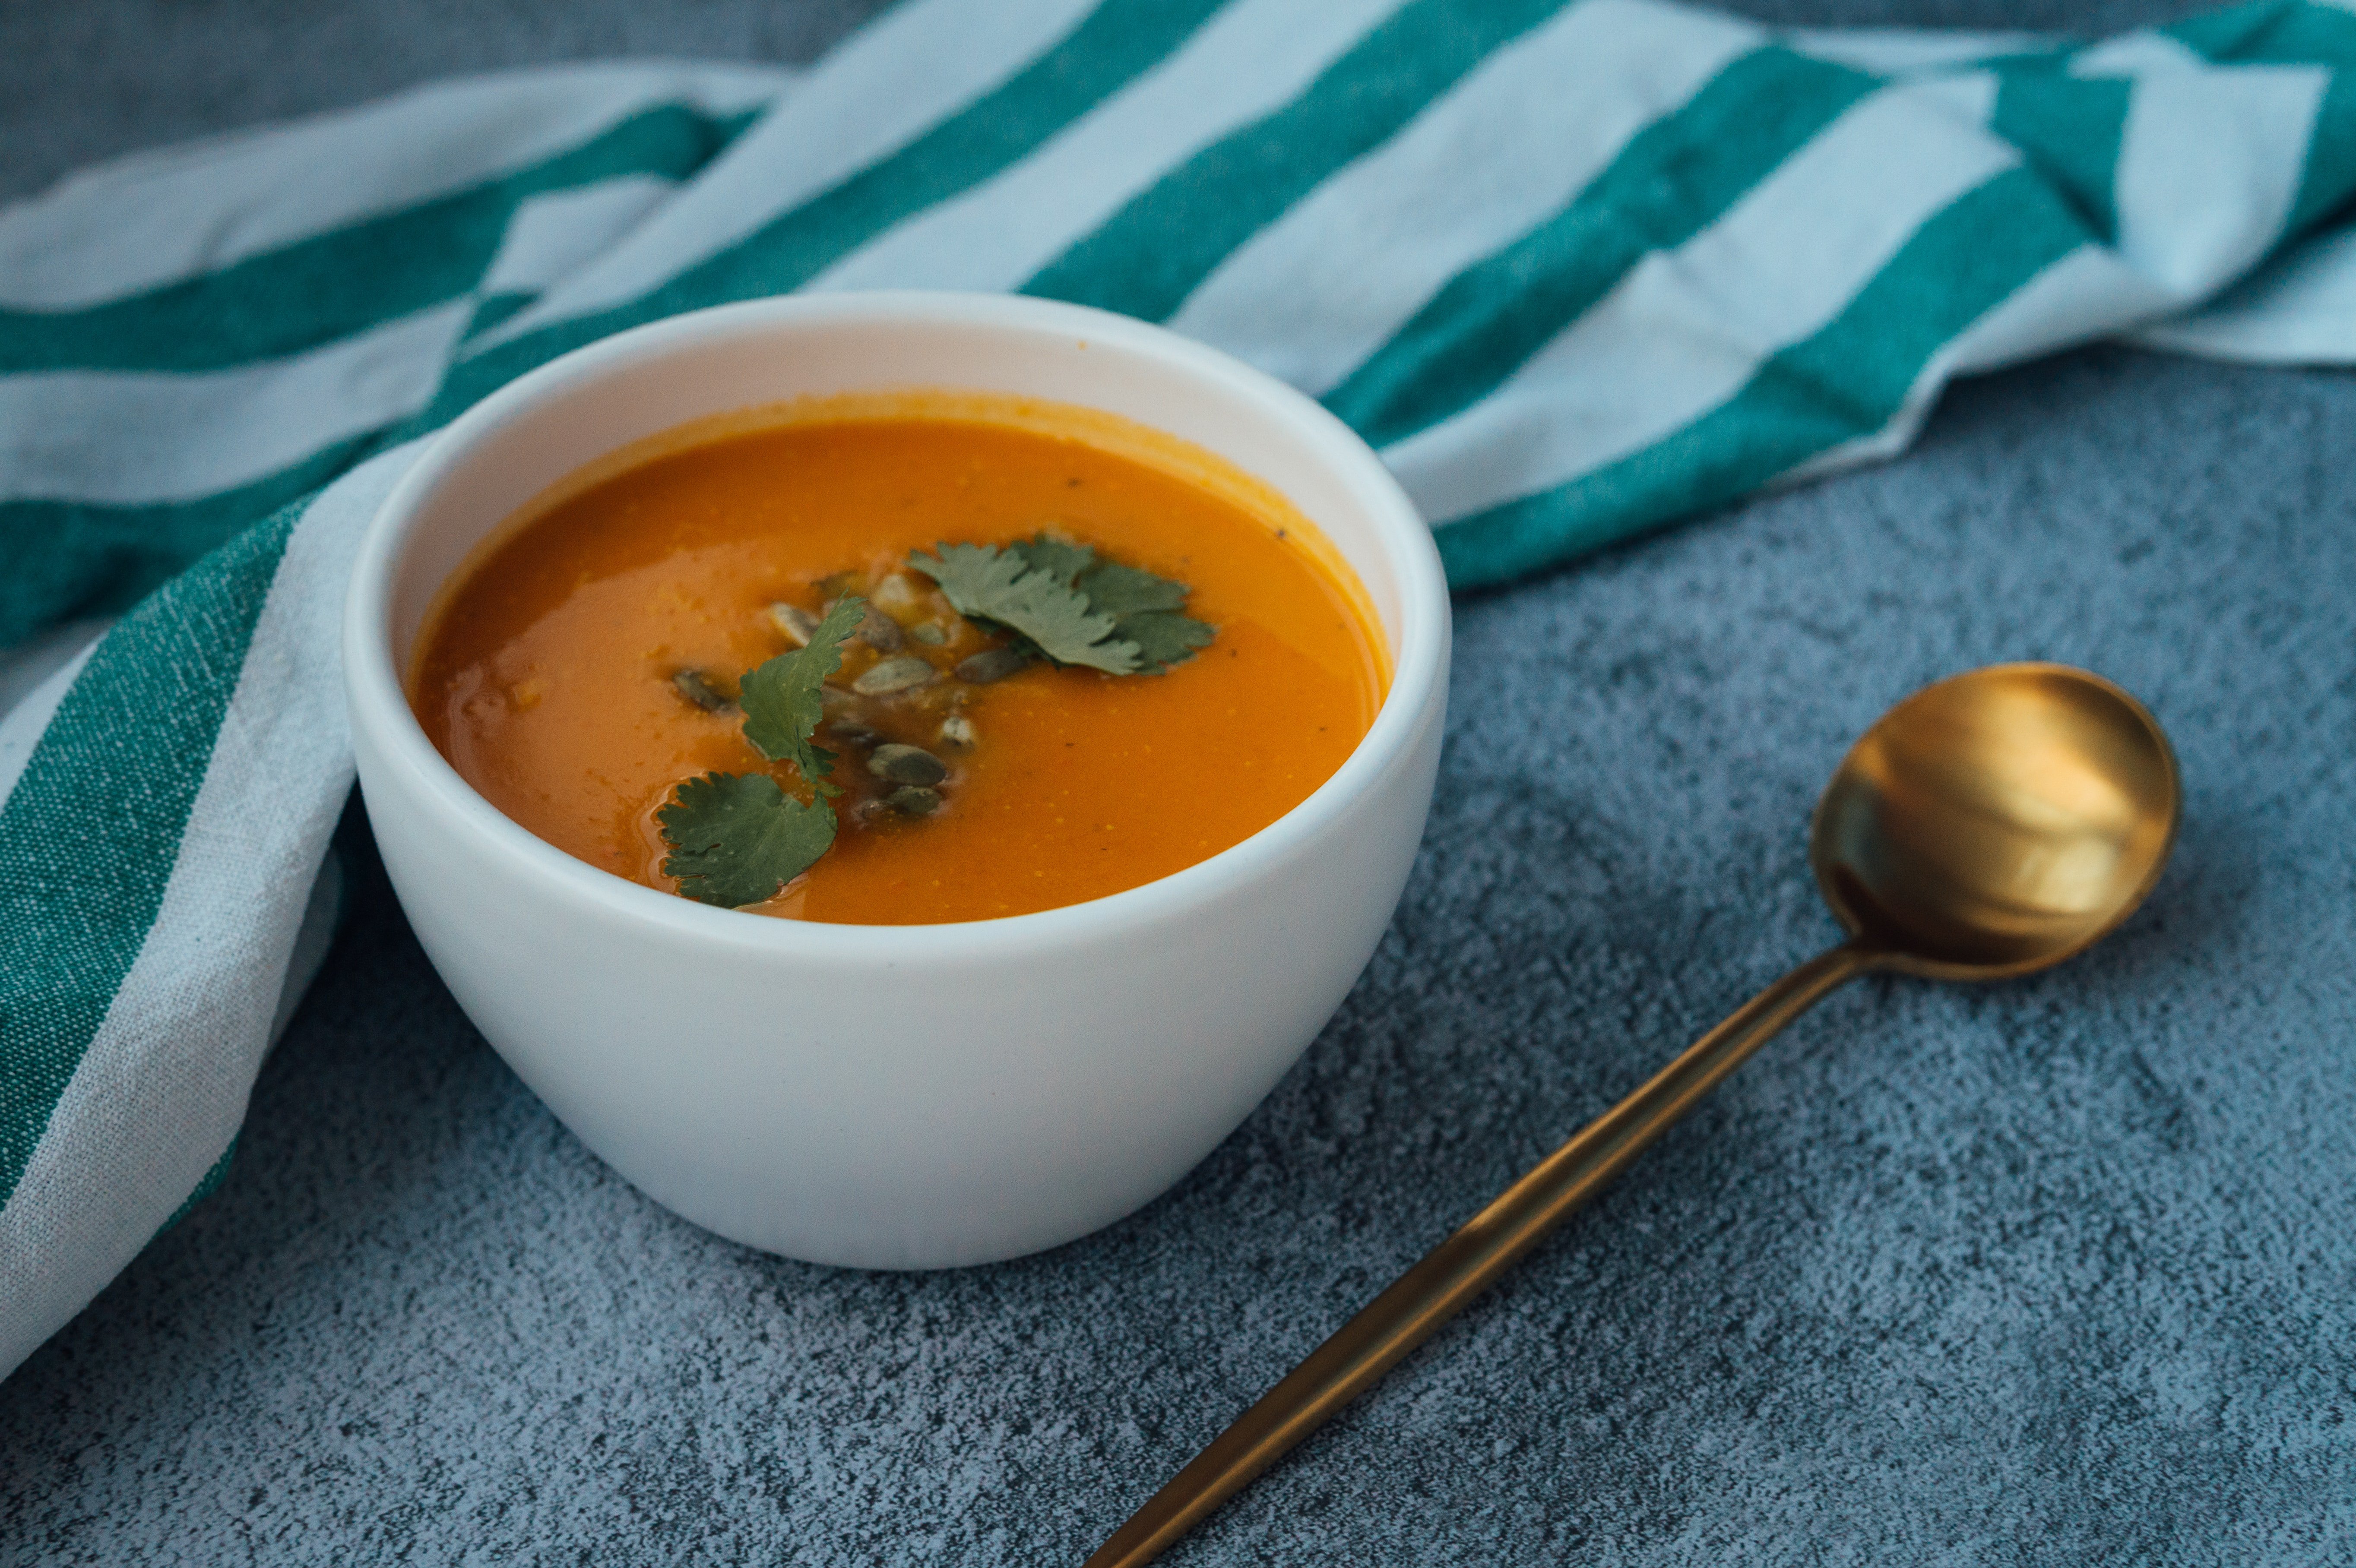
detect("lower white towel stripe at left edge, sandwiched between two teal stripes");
top-left (0, 299), bottom-right (474, 506)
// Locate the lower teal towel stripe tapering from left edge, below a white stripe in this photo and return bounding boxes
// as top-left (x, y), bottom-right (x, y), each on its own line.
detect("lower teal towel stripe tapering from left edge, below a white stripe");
top-left (0, 436), bottom-right (377, 648)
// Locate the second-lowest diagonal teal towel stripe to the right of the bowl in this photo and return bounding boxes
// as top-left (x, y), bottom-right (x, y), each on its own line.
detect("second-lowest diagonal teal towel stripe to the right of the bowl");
top-left (1324, 47), bottom-right (1880, 447)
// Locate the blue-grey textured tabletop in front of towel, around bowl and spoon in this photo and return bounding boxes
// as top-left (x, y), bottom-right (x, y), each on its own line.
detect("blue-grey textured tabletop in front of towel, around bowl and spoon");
top-left (0, 0), bottom-right (2356, 1568)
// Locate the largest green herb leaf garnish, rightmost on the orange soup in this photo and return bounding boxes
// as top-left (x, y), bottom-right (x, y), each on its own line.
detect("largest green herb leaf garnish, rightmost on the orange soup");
top-left (907, 534), bottom-right (1213, 676)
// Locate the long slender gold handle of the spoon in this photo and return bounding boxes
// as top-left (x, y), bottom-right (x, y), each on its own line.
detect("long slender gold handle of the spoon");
top-left (1086, 942), bottom-right (1875, 1568)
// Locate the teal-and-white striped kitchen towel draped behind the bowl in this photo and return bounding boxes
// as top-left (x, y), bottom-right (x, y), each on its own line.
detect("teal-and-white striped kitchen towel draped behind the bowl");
top-left (0, 0), bottom-right (2356, 1372)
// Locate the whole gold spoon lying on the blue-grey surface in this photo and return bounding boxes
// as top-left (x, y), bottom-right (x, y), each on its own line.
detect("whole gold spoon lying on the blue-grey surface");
top-left (1086, 664), bottom-right (2177, 1568)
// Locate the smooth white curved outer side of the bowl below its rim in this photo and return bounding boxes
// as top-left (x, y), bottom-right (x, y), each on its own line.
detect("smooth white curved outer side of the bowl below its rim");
top-left (361, 659), bottom-right (1442, 1269)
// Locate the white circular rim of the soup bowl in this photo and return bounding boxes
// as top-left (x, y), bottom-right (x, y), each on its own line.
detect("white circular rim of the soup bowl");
top-left (344, 290), bottom-right (1451, 965)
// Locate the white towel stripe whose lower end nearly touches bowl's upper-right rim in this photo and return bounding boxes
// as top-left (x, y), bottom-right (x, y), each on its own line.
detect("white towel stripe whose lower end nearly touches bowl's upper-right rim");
top-left (1168, 0), bottom-right (1760, 395)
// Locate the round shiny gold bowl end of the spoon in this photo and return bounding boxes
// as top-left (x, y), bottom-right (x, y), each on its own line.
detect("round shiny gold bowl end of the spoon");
top-left (1809, 664), bottom-right (2179, 980)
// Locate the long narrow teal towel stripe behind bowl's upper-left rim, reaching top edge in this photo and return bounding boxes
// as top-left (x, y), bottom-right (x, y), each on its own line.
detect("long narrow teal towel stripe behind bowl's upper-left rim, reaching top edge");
top-left (419, 0), bottom-right (1223, 433)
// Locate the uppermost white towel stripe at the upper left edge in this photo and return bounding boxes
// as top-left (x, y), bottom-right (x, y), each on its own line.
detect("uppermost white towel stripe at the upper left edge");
top-left (0, 63), bottom-right (792, 311)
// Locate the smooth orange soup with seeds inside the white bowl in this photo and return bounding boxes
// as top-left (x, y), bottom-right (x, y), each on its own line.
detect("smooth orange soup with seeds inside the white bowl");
top-left (410, 400), bottom-right (1388, 925)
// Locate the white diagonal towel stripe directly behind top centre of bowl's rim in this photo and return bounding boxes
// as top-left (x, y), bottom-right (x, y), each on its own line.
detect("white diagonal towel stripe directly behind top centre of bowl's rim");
top-left (811, 0), bottom-right (1400, 290)
